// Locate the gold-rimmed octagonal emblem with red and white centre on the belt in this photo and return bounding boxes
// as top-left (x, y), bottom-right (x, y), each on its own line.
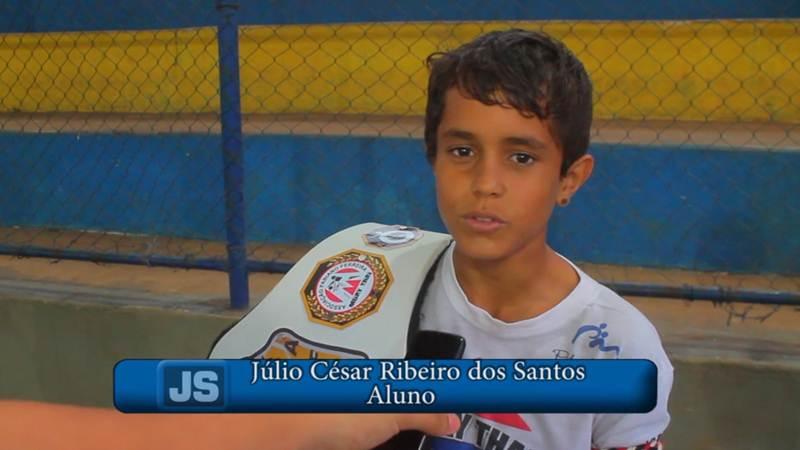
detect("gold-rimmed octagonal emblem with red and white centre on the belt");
top-left (303, 250), bottom-right (392, 328)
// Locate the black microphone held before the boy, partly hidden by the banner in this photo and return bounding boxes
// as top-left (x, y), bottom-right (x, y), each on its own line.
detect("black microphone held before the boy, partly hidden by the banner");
top-left (373, 330), bottom-right (466, 450)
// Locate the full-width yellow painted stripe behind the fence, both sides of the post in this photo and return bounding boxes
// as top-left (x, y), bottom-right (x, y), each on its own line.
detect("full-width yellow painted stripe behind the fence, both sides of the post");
top-left (0, 20), bottom-right (800, 122)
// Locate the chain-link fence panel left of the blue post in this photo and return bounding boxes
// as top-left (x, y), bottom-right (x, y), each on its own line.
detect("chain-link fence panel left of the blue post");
top-left (0, 1), bottom-right (225, 257)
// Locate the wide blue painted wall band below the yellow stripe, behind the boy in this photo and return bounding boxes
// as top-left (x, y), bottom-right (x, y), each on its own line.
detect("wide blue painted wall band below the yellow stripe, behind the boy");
top-left (0, 133), bottom-right (800, 274)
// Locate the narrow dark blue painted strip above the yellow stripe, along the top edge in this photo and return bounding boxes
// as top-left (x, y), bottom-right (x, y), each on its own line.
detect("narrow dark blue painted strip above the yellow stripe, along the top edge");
top-left (0, 0), bottom-right (800, 33)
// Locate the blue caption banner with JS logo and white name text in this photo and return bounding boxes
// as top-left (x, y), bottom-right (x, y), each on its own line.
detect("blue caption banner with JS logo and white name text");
top-left (114, 359), bottom-right (658, 413)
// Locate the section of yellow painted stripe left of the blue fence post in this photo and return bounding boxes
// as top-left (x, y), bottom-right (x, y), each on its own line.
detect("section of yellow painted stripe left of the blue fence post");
top-left (0, 29), bottom-right (219, 113)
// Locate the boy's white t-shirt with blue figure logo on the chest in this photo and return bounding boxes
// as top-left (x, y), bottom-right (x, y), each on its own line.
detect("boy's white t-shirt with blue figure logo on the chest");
top-left (420, 244), bottom-right (672, 450)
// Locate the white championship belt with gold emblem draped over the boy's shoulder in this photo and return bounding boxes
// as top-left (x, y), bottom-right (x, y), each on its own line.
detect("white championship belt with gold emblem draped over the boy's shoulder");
top-left (209, 223), bottom-right (451, 359)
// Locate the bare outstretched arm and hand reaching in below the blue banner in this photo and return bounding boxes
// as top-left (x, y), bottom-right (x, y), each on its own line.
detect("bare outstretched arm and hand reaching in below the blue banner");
top-left (0, 400), bottom-right (459, 450)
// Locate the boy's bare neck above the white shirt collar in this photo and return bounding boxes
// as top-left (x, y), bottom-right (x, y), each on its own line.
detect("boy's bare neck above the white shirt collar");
top-left (453, 241), bottom-right (579, 322)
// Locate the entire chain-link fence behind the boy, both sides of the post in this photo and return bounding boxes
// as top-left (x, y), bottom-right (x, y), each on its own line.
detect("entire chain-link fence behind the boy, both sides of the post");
top-left (0, 0), bottom-right (800, 308)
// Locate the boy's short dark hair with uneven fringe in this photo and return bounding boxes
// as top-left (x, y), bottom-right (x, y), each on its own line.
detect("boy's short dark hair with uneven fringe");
top-left (425, 29), bottom-right (592, 175)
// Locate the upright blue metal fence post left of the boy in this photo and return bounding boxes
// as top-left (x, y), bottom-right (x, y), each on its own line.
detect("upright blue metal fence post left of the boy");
top-left (217, 0), bottom-right (250, 309)
